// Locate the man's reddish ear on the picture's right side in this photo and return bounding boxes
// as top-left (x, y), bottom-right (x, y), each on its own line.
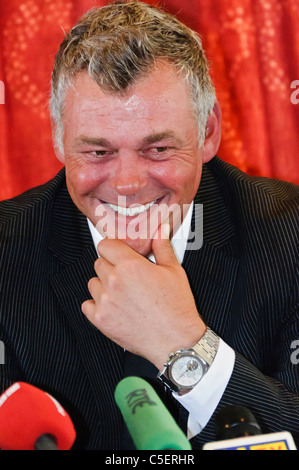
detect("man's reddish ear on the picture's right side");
top-left (202, 100), bottom-right (222, 163)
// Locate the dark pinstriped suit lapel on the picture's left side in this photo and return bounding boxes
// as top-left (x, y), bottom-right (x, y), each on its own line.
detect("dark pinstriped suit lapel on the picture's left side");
top-left (49, 183), bottom-right (123, 408)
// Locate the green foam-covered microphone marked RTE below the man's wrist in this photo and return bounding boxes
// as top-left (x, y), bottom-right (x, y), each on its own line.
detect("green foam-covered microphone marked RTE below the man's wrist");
top-left (114, 377), bottom-right (192, 450)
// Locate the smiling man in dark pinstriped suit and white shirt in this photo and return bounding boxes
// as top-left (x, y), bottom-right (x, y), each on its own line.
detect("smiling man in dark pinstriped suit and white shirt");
top-left (0, 2), bottom-right (299, 449)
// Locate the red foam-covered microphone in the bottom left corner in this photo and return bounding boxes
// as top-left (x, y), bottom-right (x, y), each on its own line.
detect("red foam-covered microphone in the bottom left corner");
top-left (0, 382), bottom-right (76, 450)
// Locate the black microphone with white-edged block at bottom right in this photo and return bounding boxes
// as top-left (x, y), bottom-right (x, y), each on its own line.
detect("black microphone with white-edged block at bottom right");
top-left (203, 405), bottom-right (296, 450)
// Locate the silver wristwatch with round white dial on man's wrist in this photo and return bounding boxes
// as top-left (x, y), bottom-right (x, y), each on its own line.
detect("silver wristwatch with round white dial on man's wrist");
top-left (157, 328), bottom-right (219, 394)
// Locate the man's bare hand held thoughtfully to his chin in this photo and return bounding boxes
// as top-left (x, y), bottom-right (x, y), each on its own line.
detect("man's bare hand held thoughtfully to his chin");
top-left (82, 226), bottom-right (206, 370)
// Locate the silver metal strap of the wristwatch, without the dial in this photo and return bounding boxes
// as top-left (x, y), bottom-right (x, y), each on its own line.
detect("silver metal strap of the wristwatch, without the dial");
top-left (157, 327), bottom-right (219, 392)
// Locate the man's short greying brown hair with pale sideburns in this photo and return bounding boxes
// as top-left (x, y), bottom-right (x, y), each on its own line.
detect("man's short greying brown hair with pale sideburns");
top-left (50, 1), bottom-right (215, 153)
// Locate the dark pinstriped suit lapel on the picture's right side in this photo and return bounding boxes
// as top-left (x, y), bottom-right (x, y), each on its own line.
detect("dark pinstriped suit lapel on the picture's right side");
top-left (182, 165), bottom-right (239, 336)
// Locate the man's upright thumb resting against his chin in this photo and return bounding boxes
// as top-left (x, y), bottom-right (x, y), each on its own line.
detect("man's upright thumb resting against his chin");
top-left (152, 223), bottom-right (178, 267)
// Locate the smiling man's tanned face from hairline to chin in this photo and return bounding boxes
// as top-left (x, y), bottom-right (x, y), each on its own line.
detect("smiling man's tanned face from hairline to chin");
top-left (62, 63), bottom-right (206, 256)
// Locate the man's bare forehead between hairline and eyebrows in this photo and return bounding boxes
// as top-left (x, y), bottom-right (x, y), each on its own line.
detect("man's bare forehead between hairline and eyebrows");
top-left (65, 62), bottom-right (192, 122)
